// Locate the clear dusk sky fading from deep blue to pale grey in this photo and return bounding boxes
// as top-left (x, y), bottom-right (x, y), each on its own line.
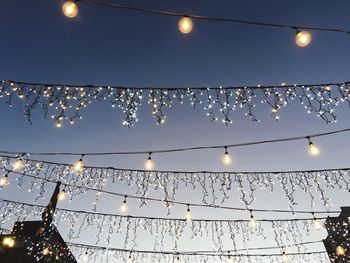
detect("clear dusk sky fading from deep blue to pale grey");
top-left (0, 0), bottom-right (350, 262)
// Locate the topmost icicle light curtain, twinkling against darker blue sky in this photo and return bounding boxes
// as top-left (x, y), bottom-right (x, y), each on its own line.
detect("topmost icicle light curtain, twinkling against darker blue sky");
top-left (0, 81), bottom-right (350, 128)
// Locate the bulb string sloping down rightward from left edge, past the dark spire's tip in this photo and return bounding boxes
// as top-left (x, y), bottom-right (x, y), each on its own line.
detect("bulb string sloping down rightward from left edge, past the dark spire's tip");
top-left (0, 170), bottom-right (341, 219)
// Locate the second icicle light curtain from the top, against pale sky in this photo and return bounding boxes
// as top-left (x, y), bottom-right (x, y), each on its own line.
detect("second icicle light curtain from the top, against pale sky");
top-left (0, 155), bottom-right (350, 212)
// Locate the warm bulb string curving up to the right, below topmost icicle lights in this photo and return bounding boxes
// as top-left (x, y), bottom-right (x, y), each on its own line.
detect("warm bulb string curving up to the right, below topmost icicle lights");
top-left (0, 128), bottom-right (350, 172)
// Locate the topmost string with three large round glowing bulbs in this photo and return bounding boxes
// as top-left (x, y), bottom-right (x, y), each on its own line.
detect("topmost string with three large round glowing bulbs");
top-left (62, 0), bottom-right (350, 47)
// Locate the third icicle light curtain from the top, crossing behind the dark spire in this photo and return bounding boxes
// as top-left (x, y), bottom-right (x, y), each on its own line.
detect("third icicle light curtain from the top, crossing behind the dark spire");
top-left (0, 199), bottom-right (325, 258)
